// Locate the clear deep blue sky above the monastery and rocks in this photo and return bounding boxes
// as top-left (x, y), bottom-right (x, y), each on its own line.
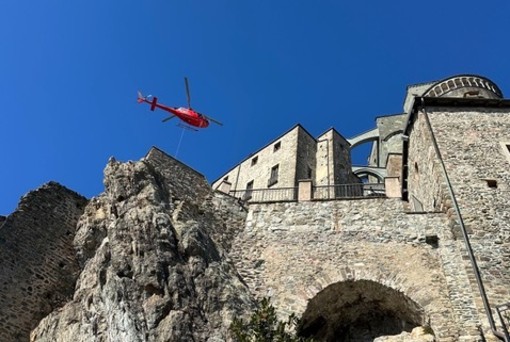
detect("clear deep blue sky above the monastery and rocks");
top-left (0, 0), bottom-right (510, 215)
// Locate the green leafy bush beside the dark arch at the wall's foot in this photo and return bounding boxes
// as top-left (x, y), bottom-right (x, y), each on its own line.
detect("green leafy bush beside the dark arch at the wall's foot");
top-left (230, 298), bottom-right (313, 342)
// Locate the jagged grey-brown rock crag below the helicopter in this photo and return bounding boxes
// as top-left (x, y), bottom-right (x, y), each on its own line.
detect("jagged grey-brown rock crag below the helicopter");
top-left (31, 149), bottom-right (253, 341)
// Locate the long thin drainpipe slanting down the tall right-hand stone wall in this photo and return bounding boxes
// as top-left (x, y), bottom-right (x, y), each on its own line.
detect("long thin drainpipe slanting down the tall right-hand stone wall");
top-left (421, 97), bottom-right (510, 342)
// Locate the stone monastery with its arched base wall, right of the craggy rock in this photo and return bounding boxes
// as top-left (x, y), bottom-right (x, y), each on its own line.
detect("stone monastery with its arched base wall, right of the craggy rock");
top-left (212, 75), bottom-right (510, 341)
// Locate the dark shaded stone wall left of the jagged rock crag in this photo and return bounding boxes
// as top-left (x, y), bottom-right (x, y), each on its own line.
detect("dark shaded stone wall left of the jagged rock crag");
top-left (0, 182), bottom-right (87, 341)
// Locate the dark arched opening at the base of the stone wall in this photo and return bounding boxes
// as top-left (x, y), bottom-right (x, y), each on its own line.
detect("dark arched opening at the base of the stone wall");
top-left (298, 280), bottom-right (427, 342)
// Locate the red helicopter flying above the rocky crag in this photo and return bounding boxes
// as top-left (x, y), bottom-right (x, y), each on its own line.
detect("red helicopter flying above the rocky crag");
top-left (138, 77), bottom-right (223, 130)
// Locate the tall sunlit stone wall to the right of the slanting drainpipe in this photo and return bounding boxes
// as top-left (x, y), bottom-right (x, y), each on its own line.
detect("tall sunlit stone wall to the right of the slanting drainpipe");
top-left (428, 108), bottom-right (510, 328)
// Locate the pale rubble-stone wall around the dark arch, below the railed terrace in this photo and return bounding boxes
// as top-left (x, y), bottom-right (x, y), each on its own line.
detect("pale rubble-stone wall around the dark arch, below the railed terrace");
top-left (233, 199), bottom-right (486, 342)
